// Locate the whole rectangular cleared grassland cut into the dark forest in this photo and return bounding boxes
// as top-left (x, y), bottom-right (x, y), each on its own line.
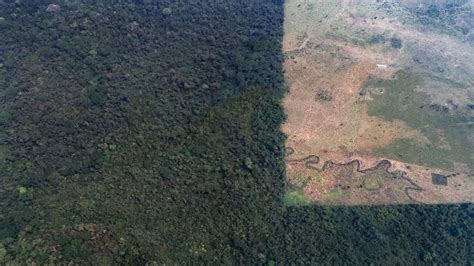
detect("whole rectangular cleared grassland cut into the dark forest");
top-left (283, 0), bottom-right (474, 205)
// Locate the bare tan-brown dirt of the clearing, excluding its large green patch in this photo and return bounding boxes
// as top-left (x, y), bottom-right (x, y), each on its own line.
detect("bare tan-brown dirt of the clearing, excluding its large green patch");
top-left (282, 0), bottom-right (474, 205)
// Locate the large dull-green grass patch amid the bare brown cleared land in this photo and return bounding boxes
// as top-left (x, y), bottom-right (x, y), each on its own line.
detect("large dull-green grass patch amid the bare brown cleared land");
top-left (366, 71), bottom-right (474, 170)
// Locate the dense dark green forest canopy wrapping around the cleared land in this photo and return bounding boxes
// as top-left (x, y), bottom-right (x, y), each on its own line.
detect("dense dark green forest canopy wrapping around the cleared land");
top-left (0, 0), bottom-right (474, 264)
